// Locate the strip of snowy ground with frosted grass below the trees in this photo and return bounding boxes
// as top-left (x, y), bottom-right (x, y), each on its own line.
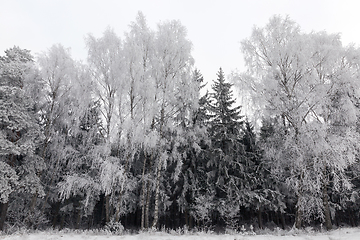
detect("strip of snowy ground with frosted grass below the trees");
top-left (0, 228), bottom-right (360, 240)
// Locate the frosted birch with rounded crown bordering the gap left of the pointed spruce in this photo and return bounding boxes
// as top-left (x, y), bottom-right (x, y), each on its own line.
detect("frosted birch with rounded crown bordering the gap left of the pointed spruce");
top-left (152, 21), bottom-right (194, 227)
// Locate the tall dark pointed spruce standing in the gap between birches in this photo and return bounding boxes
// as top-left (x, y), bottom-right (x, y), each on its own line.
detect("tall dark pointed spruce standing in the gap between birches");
top-left (207, 68), bottom-right (248, 227)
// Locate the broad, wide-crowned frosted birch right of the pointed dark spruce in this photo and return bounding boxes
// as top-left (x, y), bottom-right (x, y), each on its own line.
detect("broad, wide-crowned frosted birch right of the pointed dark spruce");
top-left (242, 16), bottom-right (356, 228)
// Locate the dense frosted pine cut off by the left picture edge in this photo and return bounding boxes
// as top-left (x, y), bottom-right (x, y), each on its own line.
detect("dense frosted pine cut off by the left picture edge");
top-left (0, 47), bottom-right (44, 230)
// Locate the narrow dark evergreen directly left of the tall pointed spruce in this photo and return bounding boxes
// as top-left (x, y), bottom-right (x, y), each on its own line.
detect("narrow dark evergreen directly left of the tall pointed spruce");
top-left (169, 69), bottom-right (208, 228)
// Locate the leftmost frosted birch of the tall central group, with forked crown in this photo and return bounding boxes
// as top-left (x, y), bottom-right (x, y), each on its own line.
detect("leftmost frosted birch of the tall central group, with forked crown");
top-left (87, 29), bottom-right (127, 222)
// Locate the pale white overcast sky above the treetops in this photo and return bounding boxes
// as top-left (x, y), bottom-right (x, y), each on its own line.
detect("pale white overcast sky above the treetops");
top-left (0, 0), bottom-right (360, 81)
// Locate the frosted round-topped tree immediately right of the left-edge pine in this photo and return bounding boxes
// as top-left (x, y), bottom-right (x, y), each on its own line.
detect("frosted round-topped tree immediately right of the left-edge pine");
top-left (36, 44), bottom-right (81, 227)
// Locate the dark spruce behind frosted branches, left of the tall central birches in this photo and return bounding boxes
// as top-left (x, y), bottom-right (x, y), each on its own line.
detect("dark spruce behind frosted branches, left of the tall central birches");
top-left (58, 99), bottom-right (105, 228)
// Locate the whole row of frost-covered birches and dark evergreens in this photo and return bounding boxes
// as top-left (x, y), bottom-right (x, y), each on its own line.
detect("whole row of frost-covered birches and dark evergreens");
top-left (0, 12), bottom-right (360, 232)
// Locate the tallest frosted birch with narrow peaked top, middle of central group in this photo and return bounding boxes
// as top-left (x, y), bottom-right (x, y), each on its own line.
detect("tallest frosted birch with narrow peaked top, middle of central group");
top-left (122, 12), bottom-right (156, 229)
